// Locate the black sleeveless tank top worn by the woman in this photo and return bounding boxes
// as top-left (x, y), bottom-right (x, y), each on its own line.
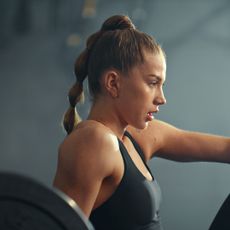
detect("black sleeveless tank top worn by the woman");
top-left (90, 132), bottom-right (163, 230)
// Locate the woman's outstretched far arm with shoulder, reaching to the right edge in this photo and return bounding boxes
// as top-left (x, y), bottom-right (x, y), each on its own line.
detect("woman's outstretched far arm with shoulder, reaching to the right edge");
top-left (127, 120), bottom-right (230, 162)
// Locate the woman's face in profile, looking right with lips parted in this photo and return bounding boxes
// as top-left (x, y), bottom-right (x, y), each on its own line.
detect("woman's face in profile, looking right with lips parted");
top-left (119, 52), bottom-right (166, 129)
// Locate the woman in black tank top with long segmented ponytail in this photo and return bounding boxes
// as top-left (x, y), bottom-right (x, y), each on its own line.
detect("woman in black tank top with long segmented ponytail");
top-left (54, 15), bottom-right (230, 230)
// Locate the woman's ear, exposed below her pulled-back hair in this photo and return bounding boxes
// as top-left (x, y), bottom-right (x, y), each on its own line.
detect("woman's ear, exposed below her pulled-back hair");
top-left (104, 70), bottom-right (121, 98)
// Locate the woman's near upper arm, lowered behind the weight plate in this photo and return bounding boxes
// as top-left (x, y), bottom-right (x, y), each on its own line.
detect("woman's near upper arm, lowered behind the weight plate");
top-left (54, 128), bottom-right (117, 216)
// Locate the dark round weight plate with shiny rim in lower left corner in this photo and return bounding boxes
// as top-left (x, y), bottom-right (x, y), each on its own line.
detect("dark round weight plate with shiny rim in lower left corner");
top-left (0, 172), bottom-right (94, 230)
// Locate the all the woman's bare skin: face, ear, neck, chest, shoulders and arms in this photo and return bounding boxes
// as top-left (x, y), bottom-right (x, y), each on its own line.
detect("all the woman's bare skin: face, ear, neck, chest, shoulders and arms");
top-left (54, 50), bottom-right (230, 217)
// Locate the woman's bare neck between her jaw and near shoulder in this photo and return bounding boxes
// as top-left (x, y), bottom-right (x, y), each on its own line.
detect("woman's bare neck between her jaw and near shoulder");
top-left (87, 101), bottom-right (127, 140)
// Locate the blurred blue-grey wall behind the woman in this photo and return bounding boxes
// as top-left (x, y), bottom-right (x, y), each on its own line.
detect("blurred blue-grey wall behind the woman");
top-left (0, 0), bottom-right (230, 230)
